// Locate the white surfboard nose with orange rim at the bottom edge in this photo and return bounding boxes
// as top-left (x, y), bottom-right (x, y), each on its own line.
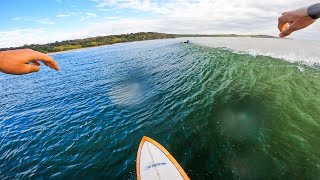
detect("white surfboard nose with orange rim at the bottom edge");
top-left (137, 136), bottom-right (190, 180)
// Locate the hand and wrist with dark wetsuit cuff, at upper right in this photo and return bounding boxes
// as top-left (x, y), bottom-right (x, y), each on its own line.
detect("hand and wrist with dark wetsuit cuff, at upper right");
top-left (278, 3), bottom-right (320, 37)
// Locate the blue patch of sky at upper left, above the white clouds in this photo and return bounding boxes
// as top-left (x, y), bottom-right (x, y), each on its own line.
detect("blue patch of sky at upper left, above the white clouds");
top-left (0, 0), bottom-right (147, 31)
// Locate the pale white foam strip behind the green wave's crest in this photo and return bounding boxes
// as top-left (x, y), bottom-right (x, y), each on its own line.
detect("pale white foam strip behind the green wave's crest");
top-left (190, 37), bottom-right (320, 65)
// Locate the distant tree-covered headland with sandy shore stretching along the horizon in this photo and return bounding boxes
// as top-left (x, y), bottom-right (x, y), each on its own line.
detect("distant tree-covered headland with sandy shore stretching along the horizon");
top-left (0, 32), bottom-right (277, 53)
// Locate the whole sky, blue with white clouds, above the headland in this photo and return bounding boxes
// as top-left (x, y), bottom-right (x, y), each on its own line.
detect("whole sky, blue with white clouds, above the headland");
top-left (0, 0), bottom-right (320, 47)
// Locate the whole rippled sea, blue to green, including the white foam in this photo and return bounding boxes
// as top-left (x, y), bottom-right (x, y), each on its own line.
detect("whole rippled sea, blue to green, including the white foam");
top-left (0, 38), bottom-right (320, 180)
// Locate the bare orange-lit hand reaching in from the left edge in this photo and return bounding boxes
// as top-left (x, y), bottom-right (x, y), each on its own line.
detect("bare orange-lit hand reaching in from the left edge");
top-left (0, 49), bottom-right (59, 75)
